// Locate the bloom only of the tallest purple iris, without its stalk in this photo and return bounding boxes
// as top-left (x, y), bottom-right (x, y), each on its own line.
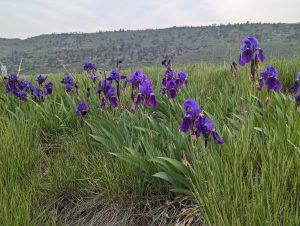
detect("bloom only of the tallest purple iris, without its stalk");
top-left (239, 37), bottom-right (266, 66)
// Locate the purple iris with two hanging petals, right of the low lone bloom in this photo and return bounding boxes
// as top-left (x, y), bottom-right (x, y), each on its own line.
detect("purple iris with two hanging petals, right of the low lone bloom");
top-left (97, 80), bottom-right (118, 108)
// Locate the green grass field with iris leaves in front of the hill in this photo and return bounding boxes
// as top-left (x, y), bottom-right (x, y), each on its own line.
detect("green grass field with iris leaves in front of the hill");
top-left (0, 58), bottom-right (300, 225)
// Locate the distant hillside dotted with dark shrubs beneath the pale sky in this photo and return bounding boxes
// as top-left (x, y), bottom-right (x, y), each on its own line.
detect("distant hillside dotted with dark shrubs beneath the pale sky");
top-left (0, 23), bottom-right (300, 73)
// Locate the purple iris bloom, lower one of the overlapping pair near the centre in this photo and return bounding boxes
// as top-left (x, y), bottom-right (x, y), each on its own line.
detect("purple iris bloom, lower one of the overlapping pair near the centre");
top-left (133, 80), bottom-right (156, 110)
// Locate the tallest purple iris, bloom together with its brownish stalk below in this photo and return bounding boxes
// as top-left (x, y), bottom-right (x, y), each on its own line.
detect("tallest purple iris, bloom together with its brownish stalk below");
top-left (239, 37), bottom-right (266, 82)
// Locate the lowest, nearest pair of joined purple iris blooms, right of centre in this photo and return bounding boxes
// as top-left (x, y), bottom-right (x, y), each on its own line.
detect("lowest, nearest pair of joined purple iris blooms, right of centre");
top-left (179, 98), bottom-right (224, 148)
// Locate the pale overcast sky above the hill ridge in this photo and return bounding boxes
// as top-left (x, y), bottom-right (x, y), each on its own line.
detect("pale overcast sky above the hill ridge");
top-left (0, 0), bottom-right (300, 39)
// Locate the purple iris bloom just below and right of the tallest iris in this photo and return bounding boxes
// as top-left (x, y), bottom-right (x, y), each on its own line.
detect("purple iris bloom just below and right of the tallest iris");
top-left (259, 66), bottom-right (282, 92)
